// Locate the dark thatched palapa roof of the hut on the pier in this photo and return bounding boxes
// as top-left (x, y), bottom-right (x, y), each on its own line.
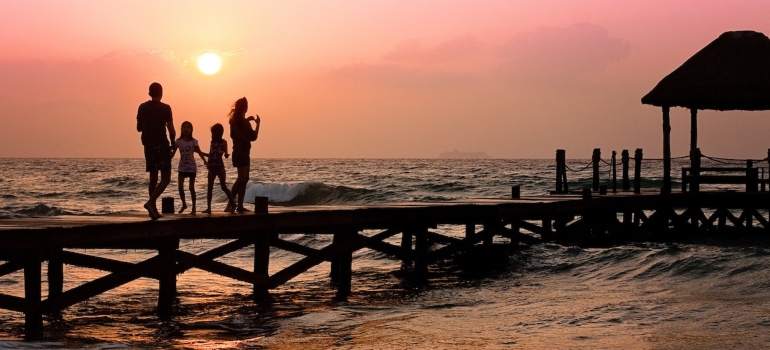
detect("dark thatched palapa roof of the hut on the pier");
top-left (642, 31), bottom-right (770, 111)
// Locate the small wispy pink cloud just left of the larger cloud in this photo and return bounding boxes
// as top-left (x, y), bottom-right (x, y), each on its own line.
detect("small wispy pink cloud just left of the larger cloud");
top-left (382, 35), bottom-right (481, 63)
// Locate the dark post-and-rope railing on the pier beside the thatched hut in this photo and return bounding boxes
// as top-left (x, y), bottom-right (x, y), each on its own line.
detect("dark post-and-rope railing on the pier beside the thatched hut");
top-left (551, 148), bottom-right (770, 194)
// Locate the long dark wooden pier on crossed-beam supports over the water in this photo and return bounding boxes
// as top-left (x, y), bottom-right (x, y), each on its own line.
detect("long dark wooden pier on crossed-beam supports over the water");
top-left (0, 188), bottom-right (770, 336)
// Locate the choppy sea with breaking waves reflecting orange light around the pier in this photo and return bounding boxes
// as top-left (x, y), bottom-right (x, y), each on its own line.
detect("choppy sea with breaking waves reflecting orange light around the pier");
top-left (0, 159), bottom-right (770, 350)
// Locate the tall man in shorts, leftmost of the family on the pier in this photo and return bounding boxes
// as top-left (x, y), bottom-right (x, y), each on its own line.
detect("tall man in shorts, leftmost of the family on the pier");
top-left (136, 83), bottom-right (176, 220)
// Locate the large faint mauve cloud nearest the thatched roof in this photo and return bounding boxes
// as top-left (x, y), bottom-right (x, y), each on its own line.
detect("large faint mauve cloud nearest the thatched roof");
top-left (495, 23), bottom-right (631, 78)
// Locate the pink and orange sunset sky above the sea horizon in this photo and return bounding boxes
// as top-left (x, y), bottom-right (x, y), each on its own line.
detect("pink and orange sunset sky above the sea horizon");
top-left (0, 0), bottom-right (770, 158)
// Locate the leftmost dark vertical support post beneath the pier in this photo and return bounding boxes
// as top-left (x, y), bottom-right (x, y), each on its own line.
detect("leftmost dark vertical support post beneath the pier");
top-left (24, 251), bottom-right (43, 338)
